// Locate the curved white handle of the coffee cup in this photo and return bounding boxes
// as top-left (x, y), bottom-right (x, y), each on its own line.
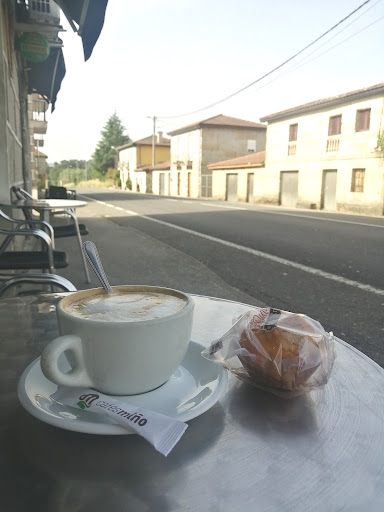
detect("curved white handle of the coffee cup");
top-left (40, 334), bottom-right (93, 388)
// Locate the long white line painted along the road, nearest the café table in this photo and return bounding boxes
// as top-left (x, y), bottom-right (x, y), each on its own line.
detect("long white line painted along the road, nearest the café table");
top-left (84, 196), bottom-right (384, 296)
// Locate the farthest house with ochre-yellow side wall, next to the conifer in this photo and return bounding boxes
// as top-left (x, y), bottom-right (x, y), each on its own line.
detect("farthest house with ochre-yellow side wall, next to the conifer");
top-left (116, 132), bottom-right (171, 193)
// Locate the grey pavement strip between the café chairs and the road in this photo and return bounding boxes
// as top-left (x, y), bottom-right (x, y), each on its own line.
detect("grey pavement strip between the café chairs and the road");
top-left (56, 197), bottom-right (264, 306)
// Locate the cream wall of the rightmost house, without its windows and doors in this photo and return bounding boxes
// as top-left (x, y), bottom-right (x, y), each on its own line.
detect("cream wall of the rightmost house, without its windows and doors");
top-left (260, 97), bottom-right (384, 215)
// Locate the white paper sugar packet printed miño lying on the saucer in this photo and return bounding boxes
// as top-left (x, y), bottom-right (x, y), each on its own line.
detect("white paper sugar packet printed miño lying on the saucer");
top-left (51, 386), bottom-right (188, 456)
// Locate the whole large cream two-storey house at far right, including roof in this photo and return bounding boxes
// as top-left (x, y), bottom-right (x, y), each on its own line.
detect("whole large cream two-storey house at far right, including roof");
top-left (254, 83), bottom-right (384, 215)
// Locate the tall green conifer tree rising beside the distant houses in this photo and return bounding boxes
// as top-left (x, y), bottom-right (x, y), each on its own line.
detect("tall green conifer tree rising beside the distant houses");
top-left (91, 112), bottom-right (131, 175)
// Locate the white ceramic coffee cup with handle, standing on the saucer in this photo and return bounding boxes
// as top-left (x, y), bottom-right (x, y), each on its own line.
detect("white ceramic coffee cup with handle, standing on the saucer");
top-left (40, 286), bottom-right (194, 395)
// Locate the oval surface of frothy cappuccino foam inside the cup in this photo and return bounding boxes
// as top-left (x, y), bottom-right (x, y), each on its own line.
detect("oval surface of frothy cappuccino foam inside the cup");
top-left (65, 292), bottom-right (187, 322)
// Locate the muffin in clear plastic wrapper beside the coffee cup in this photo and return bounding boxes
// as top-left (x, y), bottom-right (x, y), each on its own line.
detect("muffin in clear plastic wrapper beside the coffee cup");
top-left (202, 308), bottom-right (336, 398)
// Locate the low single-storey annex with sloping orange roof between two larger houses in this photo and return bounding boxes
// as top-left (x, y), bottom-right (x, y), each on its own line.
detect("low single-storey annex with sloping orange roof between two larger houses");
top-left (208, 151), bottom-right (265, 203)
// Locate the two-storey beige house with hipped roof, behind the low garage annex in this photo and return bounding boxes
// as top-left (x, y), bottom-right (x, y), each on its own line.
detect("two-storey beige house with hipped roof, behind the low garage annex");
top-left (165, 115), bottom-right (266, 198)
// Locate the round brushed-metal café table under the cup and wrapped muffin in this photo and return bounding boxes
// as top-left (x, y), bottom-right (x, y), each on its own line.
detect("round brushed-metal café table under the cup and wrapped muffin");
top-left (0, 294), bottom-right (384, 512)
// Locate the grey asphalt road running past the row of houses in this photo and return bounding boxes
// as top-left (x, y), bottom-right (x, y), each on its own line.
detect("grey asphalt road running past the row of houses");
top-left (79, 189), bottom-right (384, 367)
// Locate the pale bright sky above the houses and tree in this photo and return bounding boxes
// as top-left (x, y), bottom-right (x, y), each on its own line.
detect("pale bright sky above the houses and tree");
top-left (44, 0), bottom-right (384, 163)
